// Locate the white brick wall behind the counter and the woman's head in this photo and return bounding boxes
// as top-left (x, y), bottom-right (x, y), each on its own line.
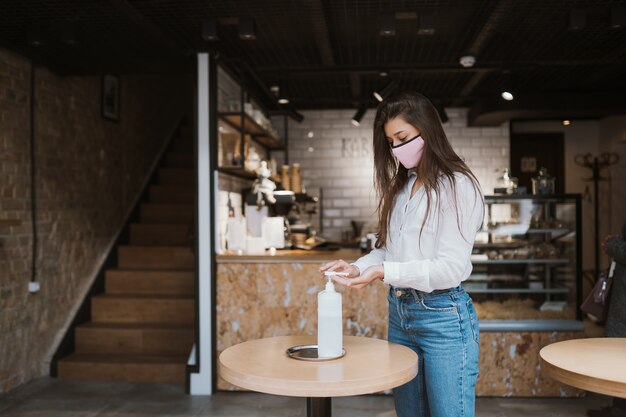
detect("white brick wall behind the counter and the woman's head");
top-left (289, 108), bottom-right (509, 239)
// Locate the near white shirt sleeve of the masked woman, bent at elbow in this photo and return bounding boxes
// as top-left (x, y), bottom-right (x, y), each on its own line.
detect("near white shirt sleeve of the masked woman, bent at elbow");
top-left (383, 177), bottom-right (484, 292)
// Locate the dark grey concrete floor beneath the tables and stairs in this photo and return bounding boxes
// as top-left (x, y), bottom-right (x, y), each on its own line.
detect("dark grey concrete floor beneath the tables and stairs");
top-left (0, 378), bottom-right (610, 417)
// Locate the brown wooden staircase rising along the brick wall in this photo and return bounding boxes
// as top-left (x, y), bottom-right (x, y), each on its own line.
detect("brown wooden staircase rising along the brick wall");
top-left (57, 138), bottom-right (196, 384)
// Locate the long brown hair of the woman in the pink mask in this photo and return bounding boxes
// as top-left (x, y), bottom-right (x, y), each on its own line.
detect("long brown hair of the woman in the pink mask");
top-left (374, 91), bottom-right (482, 248)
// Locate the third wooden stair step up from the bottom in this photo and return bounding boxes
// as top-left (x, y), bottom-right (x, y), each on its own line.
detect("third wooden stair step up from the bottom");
top-left (91, 294), bottom-right (195, 324)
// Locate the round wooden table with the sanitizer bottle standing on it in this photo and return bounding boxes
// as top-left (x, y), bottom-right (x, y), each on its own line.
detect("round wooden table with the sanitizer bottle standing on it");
top-left (218, 336), bottom-right (417, 417)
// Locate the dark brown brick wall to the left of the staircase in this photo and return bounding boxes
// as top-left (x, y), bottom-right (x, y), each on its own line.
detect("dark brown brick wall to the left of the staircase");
top-left (0, 50), bottom-right (193, 392)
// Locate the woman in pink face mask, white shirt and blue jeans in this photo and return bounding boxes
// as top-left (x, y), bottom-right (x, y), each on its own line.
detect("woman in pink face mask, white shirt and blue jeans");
top-left (320, 92), bottom-right (484, 417)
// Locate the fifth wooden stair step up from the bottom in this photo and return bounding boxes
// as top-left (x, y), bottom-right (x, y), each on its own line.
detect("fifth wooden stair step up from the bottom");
top-left (117, 246), bottom-right (195, 271)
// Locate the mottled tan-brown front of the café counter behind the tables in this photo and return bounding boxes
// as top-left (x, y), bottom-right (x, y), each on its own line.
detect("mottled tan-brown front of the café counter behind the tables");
top-left (217, 255), bottom-right (583, 396)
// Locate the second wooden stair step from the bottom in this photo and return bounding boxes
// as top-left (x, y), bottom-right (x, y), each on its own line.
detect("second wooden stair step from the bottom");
top-left (76, 322), bottom-right (194, 356)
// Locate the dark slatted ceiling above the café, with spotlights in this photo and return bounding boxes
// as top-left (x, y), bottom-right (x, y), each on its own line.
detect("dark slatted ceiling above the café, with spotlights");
top-left (0, 0), bottom-right (626, 115)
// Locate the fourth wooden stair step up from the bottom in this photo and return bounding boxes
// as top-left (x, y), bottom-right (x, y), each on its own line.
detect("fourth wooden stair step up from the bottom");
top-left (105, 269), bottom-right (195, 296)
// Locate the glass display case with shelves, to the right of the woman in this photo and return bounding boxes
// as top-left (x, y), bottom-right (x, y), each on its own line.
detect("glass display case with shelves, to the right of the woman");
top-left (464, 194), bottom-right (582, 331)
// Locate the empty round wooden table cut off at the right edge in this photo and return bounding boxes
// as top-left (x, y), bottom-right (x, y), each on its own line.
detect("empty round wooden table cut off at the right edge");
top-left (539, 337), bottom-right (626, 398)
